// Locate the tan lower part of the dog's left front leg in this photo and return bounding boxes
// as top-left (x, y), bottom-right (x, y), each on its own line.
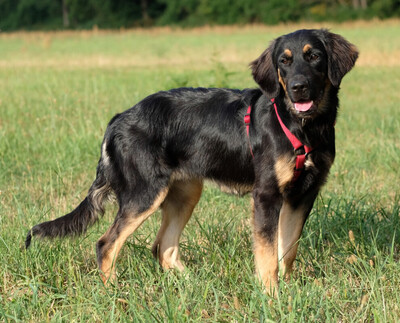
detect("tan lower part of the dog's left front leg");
top-left (254, 233), bottom-right (278, 295)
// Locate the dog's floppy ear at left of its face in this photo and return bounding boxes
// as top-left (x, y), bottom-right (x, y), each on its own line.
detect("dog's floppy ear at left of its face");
top-left (250, 40), bottom-right (280, 98)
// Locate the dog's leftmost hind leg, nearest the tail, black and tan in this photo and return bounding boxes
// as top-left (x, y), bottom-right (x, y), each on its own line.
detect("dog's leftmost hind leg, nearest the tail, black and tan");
top-left (96, 187), bottom-right (168, 284)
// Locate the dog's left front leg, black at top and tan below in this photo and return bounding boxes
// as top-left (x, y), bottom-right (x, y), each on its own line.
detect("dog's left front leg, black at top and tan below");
top-left (253, 189), bottom-right (282, 295)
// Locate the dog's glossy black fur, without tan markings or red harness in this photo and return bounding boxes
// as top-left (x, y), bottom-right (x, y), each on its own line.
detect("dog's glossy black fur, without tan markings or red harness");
top-left (26, 30), bottom-right (358, 284)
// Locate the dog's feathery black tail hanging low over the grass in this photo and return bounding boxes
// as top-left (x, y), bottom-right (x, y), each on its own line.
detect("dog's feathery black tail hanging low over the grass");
top-left (25, 161), bottom-right (111, 248)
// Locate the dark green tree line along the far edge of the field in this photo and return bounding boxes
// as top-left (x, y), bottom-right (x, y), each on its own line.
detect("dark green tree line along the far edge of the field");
top-left (0, 0), bottom-right (400, 31)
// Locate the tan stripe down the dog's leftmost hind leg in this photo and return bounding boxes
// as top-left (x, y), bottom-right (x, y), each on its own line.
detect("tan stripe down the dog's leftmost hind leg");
top-left (99, 188), bottom-right (168, 284)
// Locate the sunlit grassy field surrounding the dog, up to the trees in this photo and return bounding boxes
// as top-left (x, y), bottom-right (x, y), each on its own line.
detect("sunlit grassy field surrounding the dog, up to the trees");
top-left (0, 20), bottom-right (400, 322)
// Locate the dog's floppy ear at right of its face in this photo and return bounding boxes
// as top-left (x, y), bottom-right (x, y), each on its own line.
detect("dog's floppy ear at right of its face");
top-left (320, 29), bottom-right (358, 87)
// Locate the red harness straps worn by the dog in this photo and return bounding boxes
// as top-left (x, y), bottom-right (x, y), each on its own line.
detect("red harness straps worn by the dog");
top-left (244, 99), bottom-right (312, 182)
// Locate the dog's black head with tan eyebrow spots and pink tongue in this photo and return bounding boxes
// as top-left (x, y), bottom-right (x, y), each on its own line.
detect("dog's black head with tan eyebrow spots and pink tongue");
top-left (250, 29), bottom-right (358, 118)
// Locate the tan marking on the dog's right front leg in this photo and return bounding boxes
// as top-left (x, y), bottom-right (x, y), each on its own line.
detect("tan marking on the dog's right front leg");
top-left (278, 201), bottom-right (306, 278)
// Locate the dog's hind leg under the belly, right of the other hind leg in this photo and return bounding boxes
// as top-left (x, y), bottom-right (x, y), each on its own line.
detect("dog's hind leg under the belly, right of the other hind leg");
top-left (152, 179), bottom-right (203, 271)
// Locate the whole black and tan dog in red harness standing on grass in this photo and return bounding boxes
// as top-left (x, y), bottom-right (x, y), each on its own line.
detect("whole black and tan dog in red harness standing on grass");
top-left (25, 29), bottom-right (358, 293)
